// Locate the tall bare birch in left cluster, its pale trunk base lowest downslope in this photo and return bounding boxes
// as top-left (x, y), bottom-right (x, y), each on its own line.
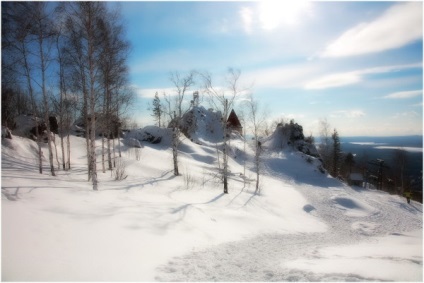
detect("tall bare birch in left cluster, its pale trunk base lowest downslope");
top-left (66, 2), bottom-right (110, 190)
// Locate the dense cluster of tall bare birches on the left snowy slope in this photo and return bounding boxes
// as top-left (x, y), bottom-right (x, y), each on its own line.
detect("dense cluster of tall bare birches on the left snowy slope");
top-left (2, 2), bottom-right (133, 190)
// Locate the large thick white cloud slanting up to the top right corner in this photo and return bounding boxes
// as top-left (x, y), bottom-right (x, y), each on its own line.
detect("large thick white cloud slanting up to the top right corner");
top-left (321, 2), bottom-right (423, 57)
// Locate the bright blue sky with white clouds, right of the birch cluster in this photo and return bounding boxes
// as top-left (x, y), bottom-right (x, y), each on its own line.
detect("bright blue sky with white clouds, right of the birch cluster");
top-left (114, 1), bottom-right (423, 136)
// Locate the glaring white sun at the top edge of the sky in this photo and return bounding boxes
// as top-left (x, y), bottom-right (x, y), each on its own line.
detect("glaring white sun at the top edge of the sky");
top-left (259, 1), bottom-right (311, 30)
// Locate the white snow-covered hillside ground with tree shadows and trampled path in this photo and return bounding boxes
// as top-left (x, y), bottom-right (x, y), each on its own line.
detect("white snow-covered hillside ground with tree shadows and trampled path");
top-left (2, 130), bottom-right (423, 281)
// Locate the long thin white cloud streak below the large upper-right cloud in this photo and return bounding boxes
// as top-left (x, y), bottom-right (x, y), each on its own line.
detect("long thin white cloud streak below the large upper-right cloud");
top-left (304, 63), bottom-right (422, 89)
